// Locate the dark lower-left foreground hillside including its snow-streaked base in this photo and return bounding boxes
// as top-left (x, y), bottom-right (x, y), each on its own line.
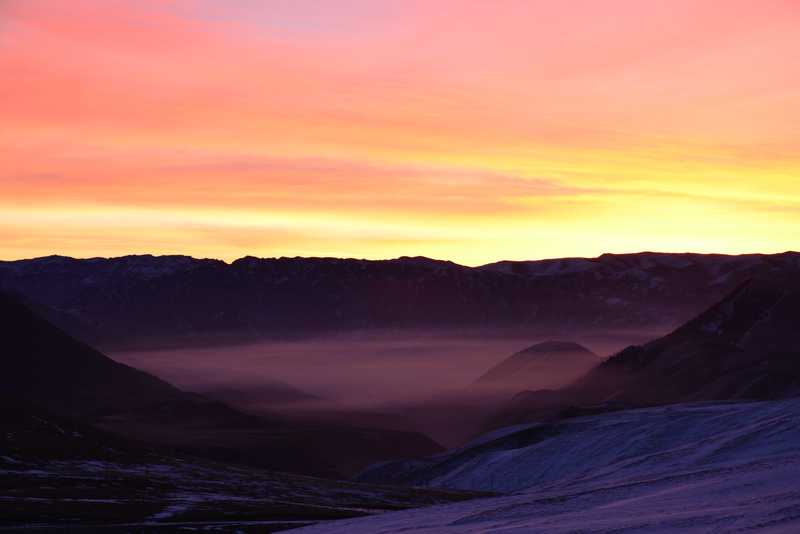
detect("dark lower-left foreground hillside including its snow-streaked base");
top-left (0, 393), bottom-right (484, 534)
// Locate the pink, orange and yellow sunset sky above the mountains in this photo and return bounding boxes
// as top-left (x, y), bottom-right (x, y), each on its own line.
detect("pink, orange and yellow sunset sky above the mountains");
top-left (0, 0), bottom-right (800, 265)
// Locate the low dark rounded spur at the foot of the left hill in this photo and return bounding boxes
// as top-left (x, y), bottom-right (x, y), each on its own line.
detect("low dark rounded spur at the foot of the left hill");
top-left (86, 401), bottom-right (444, 479)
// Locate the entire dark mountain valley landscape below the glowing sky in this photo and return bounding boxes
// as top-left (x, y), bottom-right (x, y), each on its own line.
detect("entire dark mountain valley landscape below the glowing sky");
top-left (0, 253), bottom-right (800, 533)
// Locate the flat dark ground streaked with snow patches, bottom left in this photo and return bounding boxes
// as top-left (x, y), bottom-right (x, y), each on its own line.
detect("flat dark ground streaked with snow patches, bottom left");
top-left (0, 454), bottom-right (488, 534)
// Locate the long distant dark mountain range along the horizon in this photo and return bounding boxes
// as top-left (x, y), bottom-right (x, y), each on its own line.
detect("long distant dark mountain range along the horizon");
top-left (0, 252), bottom-right (800, 348)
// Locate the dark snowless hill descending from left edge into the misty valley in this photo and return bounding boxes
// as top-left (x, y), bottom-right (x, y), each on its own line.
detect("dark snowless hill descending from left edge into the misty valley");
top-left (0, 292), bottom-right (443, 478)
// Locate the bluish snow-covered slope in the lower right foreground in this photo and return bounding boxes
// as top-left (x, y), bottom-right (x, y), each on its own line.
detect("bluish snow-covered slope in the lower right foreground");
top-left (296, 399), bottom-right (800, 534)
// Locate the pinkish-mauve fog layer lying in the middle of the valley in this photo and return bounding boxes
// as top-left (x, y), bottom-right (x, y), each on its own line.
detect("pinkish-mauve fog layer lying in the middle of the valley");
top-left (109, 330), bottom-right (665, 411)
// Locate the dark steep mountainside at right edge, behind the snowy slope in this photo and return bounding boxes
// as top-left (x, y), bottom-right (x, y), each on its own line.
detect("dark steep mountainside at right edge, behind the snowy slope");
top-left (482, 271), bottom-right (800, 431)
